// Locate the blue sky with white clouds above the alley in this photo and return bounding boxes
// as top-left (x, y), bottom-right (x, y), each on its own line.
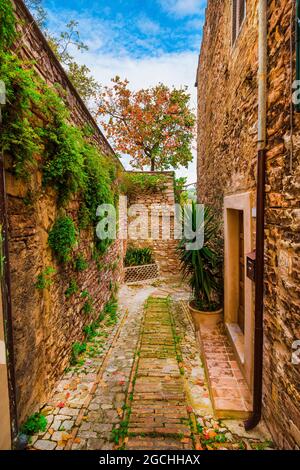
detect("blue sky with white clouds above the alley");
top-left (38, 0), bottom-right (206, 182)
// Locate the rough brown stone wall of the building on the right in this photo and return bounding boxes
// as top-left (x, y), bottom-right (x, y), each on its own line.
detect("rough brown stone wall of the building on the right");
top-left (198, 0), bottom-right (300, 449)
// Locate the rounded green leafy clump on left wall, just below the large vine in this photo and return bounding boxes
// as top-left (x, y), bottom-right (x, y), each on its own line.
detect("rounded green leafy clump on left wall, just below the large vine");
top-left (48, 217), bottom-right (76, 263)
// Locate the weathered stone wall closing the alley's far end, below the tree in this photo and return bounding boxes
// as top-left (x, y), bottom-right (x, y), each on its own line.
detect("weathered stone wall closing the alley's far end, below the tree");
top-left (128, 172), bottom-right (180, 276)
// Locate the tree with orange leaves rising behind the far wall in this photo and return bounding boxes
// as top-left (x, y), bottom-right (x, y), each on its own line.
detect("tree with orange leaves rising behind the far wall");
top-left (97, 77), bottom-right (196, 171)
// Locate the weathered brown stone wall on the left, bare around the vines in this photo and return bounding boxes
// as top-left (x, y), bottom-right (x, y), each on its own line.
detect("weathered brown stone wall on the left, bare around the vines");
top-left (6, 1), bottom-right (123, 422)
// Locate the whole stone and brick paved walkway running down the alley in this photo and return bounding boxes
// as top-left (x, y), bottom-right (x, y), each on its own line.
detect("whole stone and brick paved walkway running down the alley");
top-left (28, 282), bottom-right (270, 450)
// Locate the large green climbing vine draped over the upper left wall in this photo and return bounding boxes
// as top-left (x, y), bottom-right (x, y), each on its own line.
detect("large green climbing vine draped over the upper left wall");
top-left (0, 0), bottom-right (117, 262)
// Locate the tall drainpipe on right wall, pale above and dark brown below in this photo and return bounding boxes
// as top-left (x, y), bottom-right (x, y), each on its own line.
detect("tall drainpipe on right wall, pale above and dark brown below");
top-left (245, 0), bottom-right (268, 431)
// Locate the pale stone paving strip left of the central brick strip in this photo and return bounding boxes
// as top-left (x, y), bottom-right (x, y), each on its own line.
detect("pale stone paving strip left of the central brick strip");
top-left (31, 286), bottom-right (155, 450)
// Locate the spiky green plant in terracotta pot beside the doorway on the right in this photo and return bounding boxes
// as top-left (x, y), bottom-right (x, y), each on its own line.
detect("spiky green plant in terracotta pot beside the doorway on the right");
top-left (178, 202), bottom-right (223, 329)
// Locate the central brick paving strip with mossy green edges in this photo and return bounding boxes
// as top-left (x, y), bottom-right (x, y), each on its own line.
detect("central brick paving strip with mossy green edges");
top-left (125, 297), bottom-right (193, 450)
